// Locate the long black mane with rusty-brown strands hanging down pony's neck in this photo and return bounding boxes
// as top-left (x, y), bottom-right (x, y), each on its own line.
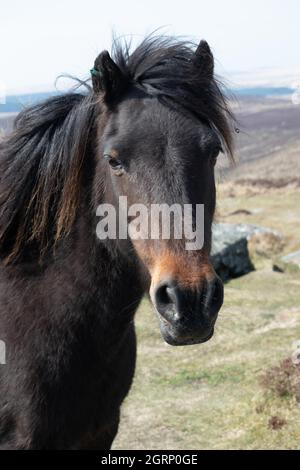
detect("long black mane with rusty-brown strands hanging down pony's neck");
top-left (0, 93), bottom-right (96, 264)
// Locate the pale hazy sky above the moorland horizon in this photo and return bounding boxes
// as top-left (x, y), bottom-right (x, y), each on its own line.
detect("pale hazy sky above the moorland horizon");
top-left (0, 0), bottom-right (300, 91)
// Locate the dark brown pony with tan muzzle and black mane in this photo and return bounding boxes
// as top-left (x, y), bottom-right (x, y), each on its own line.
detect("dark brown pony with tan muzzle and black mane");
top-left (0, 37), bottom-right (232, 449)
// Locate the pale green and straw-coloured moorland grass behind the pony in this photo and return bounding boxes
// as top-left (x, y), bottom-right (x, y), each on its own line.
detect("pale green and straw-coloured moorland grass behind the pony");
top-left (114, 185), bottom-right (300, 450)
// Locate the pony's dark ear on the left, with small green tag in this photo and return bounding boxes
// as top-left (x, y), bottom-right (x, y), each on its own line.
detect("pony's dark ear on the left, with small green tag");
top-left (91, 51), bottom-right (127, 104)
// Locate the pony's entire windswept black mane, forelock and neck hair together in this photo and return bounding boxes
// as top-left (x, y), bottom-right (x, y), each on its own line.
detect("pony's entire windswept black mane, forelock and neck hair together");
top-left (0, 36), bottom-right (233, 263)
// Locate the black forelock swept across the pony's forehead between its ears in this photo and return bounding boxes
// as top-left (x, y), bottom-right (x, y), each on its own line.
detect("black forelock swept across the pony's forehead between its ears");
top-left (112, 35), bottom-right (235, 156)
